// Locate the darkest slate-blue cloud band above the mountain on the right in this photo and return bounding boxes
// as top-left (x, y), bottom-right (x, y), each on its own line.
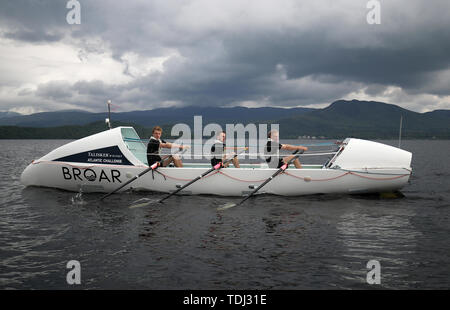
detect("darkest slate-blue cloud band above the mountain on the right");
top-left (220, 23), bottom-right (450, 95)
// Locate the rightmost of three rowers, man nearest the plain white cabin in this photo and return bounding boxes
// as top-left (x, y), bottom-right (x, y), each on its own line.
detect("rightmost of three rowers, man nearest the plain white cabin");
top-left (266, 130), bottom-right (308, 169)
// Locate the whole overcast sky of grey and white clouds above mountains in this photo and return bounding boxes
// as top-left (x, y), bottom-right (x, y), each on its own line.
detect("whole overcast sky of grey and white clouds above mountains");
top-left (0, 0), bottom-right (450, 113)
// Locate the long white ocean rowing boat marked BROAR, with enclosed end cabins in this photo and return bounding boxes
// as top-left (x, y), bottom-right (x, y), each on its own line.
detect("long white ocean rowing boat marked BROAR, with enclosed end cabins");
top-left (21, 127), bottom-right (412, 196)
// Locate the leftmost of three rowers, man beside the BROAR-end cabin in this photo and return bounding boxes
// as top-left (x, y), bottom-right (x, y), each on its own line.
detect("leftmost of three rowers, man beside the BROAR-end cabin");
top-left (147, 126), bottom-right (189, 167)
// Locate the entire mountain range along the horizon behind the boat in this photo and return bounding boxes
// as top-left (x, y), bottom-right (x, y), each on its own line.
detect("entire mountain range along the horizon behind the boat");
top-left (0, 100), bottom-right (450, 139)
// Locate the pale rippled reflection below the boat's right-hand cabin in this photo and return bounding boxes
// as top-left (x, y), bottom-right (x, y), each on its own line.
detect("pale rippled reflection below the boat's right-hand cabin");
top-left (336, 202), bottom-right (422, 288)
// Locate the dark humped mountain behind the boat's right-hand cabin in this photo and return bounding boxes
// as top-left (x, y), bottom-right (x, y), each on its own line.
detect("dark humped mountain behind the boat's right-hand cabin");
top-left (277, 100), bottom-right (450, 138)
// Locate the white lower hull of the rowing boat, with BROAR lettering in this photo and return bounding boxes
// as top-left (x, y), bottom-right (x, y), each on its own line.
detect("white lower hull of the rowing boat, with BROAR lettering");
top-left (22, 162), bottom-right (410, 196)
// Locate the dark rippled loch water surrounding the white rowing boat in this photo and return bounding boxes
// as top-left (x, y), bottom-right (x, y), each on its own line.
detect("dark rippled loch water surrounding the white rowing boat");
top-left (0, 140), bottom-right (450, 289)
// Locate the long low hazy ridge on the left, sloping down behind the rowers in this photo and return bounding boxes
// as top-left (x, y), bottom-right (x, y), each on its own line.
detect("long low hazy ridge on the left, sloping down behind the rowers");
top-left (0, 107), bottom-right (314, 127)
